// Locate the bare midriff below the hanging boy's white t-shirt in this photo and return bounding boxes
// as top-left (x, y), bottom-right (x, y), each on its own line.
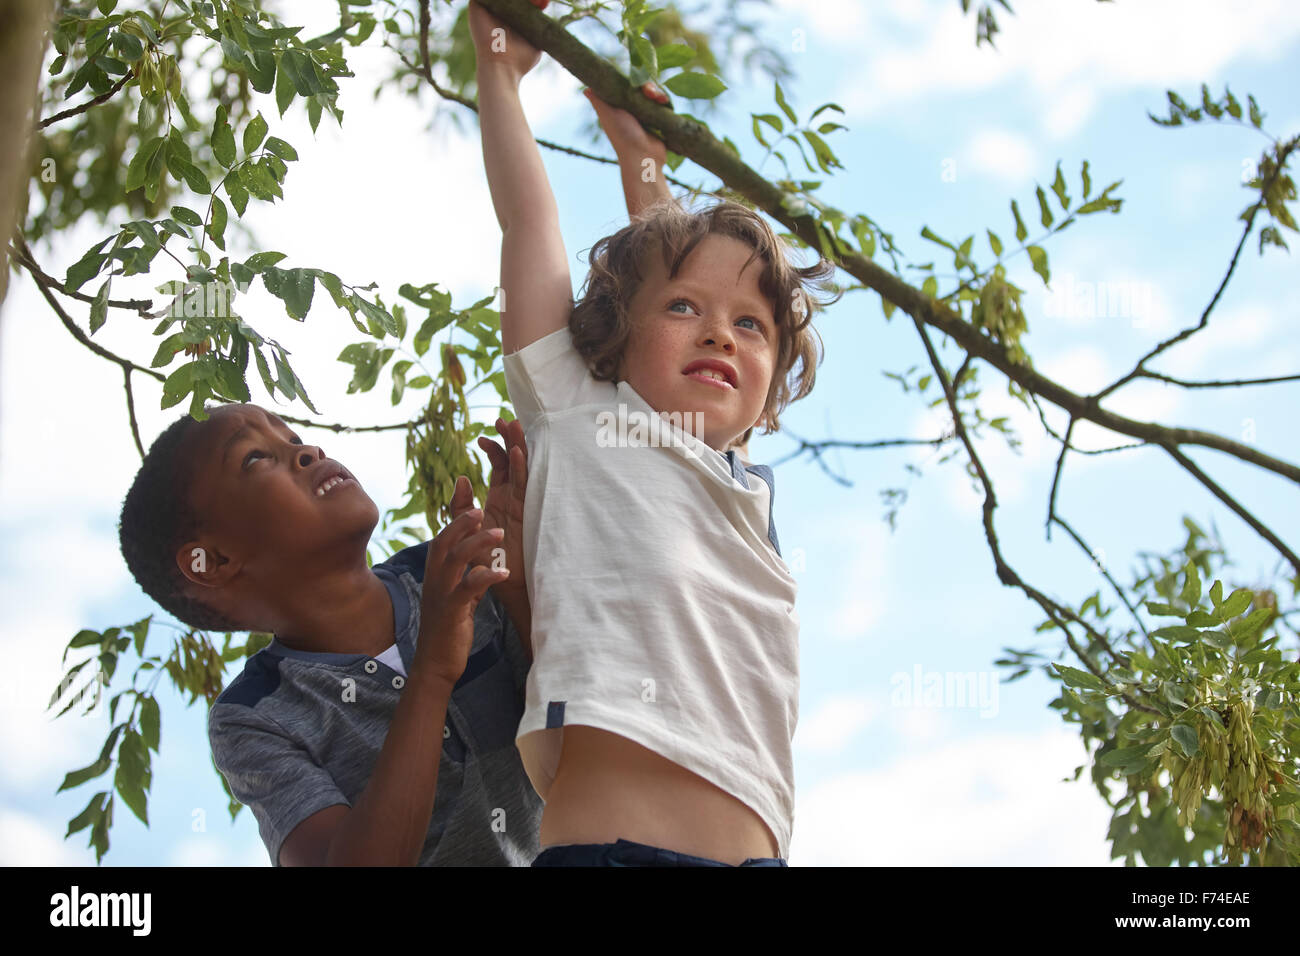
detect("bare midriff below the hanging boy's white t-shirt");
top-left (538, 724), bottom-right (777, 865)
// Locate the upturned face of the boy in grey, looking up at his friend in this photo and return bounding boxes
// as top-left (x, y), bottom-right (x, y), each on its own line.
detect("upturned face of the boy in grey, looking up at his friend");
top-left (180, 405), bottom-right (378, 580)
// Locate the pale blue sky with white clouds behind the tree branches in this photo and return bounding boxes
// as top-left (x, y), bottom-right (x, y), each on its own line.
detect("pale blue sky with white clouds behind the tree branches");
top-left (0, 0), bottom-right (1300, 865)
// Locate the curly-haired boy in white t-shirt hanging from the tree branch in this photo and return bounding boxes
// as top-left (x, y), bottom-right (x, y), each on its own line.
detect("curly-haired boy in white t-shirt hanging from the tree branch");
top-left (469, 3), bottom-right (833, 866)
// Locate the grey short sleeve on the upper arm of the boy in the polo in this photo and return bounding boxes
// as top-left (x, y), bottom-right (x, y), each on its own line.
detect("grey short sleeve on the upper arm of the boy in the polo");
top-left (208, 704), bottom-right (352, 866)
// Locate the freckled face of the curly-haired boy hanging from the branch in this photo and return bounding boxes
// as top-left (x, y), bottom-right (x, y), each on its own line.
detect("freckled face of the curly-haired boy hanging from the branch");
top-left (620, 235), bottom-right (777, 450)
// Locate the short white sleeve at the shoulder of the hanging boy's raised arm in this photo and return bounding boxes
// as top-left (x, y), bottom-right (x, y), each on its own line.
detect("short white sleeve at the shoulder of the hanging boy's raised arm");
top-left (503, 326), bottom-right (618, 429)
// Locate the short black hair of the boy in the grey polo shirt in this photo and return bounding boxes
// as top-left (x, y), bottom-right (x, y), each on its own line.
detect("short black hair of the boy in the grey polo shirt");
top-left (117, 407), bottom-right (250, 631)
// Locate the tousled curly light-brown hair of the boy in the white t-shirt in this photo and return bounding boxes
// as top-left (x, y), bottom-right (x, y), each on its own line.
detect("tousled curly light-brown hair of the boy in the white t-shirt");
top-left (569, 199), bottom-right (842, 445)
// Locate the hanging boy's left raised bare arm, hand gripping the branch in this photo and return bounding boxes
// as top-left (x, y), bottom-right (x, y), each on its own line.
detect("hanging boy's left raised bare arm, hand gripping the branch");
top-left (469, 3), bottom-right (573, 355)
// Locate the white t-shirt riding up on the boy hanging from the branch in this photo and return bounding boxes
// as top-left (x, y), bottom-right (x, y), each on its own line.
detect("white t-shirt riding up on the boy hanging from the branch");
top-left (504, 328), bottom-right (798, 857)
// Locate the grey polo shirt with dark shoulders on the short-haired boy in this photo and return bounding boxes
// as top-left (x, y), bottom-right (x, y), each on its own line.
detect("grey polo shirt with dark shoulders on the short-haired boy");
top-left (208, 542), bottom-right (543, 866)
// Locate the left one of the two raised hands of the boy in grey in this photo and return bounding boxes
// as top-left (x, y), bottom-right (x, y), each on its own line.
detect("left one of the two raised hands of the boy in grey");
top-left (416, 494), bottom-right (510, 685)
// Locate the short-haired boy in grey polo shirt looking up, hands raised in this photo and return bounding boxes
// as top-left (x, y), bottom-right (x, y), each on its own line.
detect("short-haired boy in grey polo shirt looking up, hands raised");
top-left (121, 405), bottom-right (542, 865)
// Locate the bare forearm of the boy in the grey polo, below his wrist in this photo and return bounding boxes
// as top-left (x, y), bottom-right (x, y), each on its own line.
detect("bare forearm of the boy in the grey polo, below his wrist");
top-left (326, 652), bottom-right (452, 866)
